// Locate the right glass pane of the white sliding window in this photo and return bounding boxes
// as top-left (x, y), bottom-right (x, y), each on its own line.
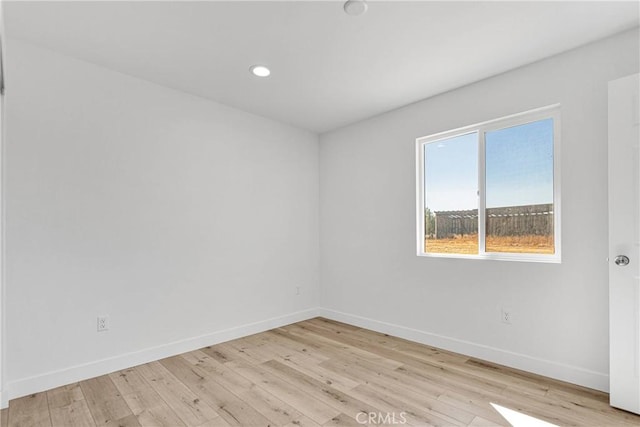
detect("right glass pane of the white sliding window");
top-left (485, 119), bottom-right (555, 254)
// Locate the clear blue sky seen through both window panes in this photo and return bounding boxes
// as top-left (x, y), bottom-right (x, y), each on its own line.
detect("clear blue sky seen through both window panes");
top-left (425, 119), bottom-right (553, 211)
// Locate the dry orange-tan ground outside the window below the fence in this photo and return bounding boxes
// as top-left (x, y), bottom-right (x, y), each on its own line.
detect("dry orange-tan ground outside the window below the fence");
top-left (425, 234), bottom-right (554, 255)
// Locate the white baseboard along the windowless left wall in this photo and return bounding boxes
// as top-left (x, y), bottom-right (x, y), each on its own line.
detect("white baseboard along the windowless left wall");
top-left (6, 308), bottom-right (320, 408)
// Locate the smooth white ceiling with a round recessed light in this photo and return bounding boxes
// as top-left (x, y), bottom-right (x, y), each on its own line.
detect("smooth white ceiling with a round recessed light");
top-left (4, 1), bottom-right (639, 132)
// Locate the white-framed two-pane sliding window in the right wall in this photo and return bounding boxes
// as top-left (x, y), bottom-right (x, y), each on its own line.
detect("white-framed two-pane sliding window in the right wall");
top-left (417, 106), bottom-right (560, 262)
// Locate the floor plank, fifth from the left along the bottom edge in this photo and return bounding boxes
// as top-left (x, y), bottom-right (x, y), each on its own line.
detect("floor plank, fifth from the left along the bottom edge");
top-left (136, 362), bottom-right (228, 426)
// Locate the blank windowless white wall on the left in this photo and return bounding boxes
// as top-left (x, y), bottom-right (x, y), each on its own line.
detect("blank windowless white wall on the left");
top-left (4, 40), bottom-right (319, 398)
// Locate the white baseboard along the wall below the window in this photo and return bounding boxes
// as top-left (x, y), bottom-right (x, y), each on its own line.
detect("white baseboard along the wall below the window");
top-left (320, 309), bottom-right (609, 392)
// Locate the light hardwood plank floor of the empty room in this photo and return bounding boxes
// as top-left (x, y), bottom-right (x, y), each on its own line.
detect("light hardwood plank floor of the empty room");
top-left (2, 318), bottom-right (640, 427)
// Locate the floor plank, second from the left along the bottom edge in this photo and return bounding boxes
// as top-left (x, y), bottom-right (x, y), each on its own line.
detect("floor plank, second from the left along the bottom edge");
top-left (47, 383), bottom-right (96, 427)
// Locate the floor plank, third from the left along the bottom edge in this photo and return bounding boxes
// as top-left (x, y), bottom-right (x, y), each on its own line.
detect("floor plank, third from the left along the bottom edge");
top-left (80, 375), bottom-right (140, 427)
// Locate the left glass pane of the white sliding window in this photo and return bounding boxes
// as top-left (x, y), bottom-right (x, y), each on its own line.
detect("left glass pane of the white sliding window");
top-left (424, 132), bottom-right (478, 254)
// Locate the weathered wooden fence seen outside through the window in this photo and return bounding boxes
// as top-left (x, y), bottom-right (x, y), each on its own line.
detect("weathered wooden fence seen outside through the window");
top-left (427, 204), bottom-right (553, 239)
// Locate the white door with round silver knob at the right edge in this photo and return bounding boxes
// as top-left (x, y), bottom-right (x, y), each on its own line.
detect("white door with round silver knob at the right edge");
top-left (609, 74), bottom-right (640, 413)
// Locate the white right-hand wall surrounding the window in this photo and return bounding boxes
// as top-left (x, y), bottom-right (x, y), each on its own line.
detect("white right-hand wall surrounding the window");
top-left (320, 30), bottom-right (639, 389)
